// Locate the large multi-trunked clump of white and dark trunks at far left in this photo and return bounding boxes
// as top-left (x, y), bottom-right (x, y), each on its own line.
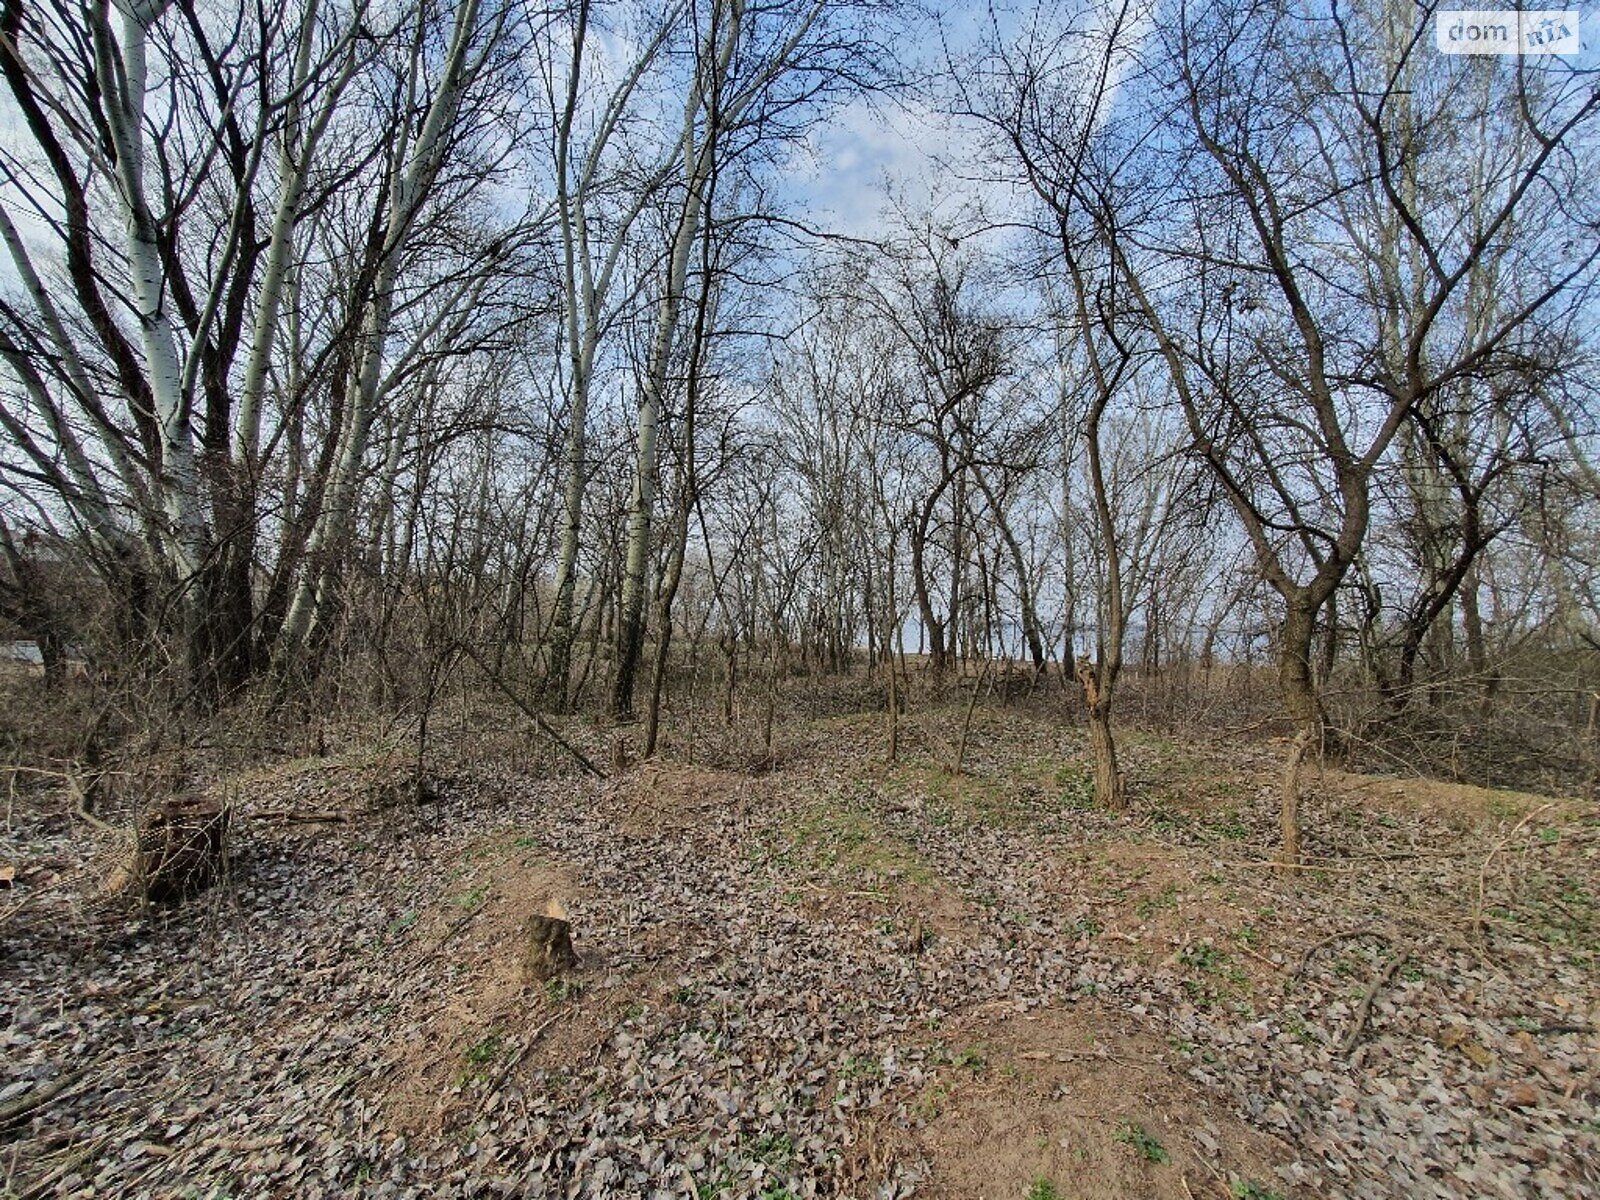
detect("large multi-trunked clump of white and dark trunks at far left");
top-left (0, 0), bottom-right (538, 704)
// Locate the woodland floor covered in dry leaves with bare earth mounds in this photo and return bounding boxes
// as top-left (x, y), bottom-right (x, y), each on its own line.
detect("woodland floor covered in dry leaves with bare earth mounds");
top-left (0, 709), bottom-right (1600, 1200)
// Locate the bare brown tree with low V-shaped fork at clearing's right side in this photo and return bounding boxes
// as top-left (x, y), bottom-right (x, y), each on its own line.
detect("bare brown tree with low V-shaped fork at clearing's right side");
top-left (1126, 5), bottom-right (1600, 862)
